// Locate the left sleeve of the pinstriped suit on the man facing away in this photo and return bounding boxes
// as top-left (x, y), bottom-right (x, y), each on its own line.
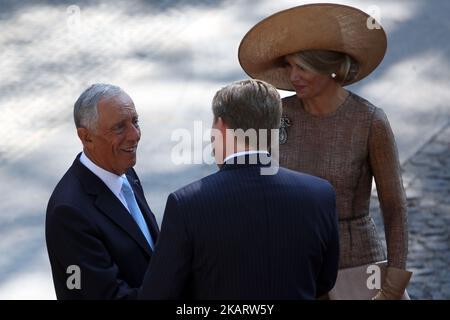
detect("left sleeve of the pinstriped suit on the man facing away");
top-left (139, 194), bottom-right (193, 300)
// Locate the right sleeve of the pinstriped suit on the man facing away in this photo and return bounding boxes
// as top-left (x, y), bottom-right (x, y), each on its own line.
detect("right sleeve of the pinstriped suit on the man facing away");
top-left (316, 186), bottom-right (339, 297)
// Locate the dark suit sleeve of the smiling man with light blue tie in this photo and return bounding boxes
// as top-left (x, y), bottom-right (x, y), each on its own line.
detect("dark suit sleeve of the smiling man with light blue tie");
top-left (46, 205), bottom-right (138, 299)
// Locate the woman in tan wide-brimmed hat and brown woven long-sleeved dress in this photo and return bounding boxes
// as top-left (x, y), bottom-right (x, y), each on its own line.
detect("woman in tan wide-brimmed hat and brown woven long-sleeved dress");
top-left (239, 4), bottom-right (411, 299)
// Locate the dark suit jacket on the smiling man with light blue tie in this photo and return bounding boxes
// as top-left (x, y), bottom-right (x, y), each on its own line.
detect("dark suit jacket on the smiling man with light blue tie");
top-left (46, 155), bottom-right (159, 299)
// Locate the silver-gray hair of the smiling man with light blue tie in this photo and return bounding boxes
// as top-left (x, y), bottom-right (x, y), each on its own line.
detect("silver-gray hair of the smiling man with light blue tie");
top-left (73, 83), bottom-right (126, 130)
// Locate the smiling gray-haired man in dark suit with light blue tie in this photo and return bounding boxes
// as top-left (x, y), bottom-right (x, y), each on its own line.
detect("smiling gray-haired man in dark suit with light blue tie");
top-left (46, 84), bottom-right (159, 299)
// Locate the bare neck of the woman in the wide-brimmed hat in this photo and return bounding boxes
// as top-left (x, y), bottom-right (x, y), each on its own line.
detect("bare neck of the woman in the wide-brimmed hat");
top-left (302, 85), bottom-right (349, 116)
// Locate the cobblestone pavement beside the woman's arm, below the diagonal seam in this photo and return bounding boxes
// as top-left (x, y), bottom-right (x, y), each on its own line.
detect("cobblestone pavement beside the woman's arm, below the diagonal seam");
top-left (372, 120), bottom-right (450, 299)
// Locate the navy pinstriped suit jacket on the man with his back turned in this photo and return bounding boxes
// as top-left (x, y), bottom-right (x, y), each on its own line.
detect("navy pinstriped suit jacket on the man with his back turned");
top-left (140, 156), bottom-right (339, 299)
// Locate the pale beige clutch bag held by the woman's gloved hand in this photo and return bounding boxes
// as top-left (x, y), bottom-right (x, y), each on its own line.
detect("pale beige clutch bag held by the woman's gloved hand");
top-left (328, 261), bottom-right (409, 300)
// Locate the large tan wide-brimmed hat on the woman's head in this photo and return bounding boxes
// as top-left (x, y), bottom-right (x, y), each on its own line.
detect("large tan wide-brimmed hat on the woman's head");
top-left (238, 3), bottom-right (387, 91)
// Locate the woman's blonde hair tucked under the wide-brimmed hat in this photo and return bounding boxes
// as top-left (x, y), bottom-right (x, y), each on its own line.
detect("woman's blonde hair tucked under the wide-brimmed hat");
top-left (289, 50), bottom-right (358, 83)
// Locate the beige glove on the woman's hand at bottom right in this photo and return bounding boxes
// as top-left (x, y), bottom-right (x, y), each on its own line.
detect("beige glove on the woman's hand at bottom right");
top-left (372, 267), bottom-right (412, 300)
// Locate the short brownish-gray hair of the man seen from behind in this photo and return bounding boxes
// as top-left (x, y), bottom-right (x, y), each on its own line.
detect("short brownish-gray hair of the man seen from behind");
top-left (212, 79), bottom-right (282, 131)
